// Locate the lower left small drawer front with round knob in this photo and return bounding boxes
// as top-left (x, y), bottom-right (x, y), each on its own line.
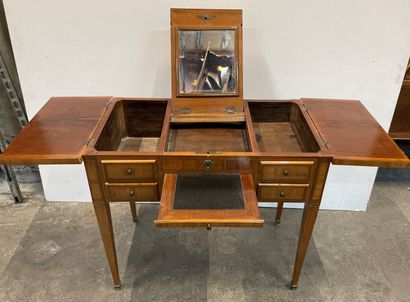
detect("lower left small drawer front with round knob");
top-left (106, 182), bottom-right (159, 201)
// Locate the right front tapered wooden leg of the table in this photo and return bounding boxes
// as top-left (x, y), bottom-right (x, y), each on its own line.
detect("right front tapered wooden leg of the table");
top-left (290, 203), bottom-right (319, 289)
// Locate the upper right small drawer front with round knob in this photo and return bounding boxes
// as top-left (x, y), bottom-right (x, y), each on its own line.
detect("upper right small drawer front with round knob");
top-left (259, 161), bottom-right (314, 183)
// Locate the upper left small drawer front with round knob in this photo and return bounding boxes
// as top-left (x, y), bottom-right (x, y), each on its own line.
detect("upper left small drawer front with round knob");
top-left (102, 160), bottom-right (156, 181)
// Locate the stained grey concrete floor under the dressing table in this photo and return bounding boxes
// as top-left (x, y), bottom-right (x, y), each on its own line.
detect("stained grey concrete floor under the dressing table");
top-left (0, 170), bottom-right (410, 301)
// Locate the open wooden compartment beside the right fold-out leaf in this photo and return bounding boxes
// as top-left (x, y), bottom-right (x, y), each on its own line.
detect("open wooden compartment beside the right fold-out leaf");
top-left (248, 102), bottom-right (320, 152)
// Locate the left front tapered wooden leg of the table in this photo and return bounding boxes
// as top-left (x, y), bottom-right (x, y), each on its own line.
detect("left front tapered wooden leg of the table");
top-left (94, 202), bottom-right (121, 288)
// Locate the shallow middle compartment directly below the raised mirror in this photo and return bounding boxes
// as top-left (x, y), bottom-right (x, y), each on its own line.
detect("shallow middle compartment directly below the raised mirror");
top-left (167, 123), bottom-right (249, 153)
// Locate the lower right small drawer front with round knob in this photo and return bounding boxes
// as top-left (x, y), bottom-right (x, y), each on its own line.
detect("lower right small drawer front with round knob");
top-left (258, 183), bottom-right (309, 202)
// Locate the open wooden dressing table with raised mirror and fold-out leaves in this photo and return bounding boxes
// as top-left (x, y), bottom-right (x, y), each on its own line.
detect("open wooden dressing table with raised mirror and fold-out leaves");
top-left (0, 9), bottom-right (410, 288)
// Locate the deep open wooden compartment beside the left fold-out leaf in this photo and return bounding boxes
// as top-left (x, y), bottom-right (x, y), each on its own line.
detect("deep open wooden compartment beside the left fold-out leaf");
top-left (95, 100), bottom-right (167, 152)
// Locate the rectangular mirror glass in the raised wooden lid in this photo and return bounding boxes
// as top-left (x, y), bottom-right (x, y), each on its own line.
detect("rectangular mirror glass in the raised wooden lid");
top-left (178, 29), bottom-right (238, 94)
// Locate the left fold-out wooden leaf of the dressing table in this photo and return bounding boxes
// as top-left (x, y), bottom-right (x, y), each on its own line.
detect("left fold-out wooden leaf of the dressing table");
top-left (0, 97), bottom-right (111, 165)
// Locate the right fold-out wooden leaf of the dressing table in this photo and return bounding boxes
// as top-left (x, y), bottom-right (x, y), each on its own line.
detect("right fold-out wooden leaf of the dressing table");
top-left (302, 99), bottom-right (410, 167)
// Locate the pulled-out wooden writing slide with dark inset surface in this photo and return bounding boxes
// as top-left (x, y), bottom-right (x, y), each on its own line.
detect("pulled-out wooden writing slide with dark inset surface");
top-left (155, 173), bottom-right (263, 227)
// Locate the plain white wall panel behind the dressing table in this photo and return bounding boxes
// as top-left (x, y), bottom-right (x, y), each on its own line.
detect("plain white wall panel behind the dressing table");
top-left (4, 0), bottom-right (410, 210)
